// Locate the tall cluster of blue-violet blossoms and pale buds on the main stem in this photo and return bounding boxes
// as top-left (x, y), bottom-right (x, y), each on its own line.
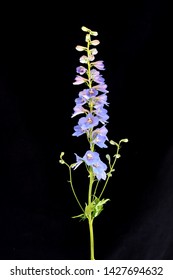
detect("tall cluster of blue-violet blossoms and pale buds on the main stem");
top-left (72, 26), bottom-right (109, 180)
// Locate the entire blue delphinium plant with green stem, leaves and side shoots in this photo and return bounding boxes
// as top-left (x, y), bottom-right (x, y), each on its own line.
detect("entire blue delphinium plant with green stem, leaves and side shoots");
top-left (59, 26), bottom-right (128, 260)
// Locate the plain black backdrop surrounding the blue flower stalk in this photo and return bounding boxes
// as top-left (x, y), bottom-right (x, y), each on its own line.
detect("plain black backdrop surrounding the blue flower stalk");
top-left (0, 0), bottom-right (173, 260)
